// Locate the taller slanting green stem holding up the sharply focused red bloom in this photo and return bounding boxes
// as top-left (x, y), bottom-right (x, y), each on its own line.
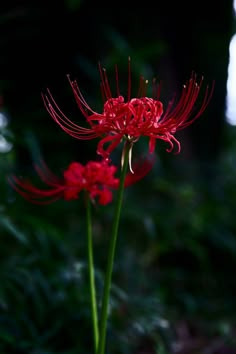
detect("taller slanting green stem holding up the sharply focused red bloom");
top-left (97, 143), bottom-right (131, 354)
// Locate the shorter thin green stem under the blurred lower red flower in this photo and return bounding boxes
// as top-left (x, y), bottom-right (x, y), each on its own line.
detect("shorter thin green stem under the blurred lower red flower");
top-left (85, 194), bottom-right (99, 352)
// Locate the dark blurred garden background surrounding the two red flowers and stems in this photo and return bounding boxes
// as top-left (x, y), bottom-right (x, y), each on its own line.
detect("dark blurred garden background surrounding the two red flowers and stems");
top-left (0, 0), bottom-right (236, 354)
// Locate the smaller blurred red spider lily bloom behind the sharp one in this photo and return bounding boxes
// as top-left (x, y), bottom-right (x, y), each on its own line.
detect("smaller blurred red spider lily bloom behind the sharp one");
top-left (8, 157), bottom-right (154, 205)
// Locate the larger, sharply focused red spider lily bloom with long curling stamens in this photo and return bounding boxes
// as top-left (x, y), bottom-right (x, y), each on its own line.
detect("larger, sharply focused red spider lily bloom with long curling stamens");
top-left (43, 60), bottom-right (214, 158)
